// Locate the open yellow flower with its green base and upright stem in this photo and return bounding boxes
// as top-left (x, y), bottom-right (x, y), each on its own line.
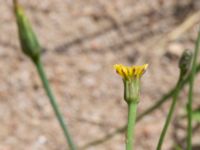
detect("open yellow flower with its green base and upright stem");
top-left (113, 64), bottom-right (148, 150)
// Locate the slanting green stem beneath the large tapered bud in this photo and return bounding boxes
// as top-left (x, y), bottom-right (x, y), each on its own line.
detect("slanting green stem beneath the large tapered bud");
top-left (35, 59), bottom-right (76, 150)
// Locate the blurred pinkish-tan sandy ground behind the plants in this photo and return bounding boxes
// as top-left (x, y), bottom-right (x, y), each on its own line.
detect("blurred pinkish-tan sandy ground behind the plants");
top-left (0, 0), bottom-right (200, 150)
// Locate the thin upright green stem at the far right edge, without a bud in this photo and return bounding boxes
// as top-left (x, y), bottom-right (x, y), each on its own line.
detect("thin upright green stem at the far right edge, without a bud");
top-left (187, 31), bottom-right (200, 150)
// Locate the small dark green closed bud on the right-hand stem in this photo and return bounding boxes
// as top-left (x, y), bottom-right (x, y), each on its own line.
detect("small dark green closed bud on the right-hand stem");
top-left (179, 50), bottom-right (192, 78)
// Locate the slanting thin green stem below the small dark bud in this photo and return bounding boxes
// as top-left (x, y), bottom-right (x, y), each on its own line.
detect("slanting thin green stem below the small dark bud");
top-left (156, 77), bottom-right (182, 150)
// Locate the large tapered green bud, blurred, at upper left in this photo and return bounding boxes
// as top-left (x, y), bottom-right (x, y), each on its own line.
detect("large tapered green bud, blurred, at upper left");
top-left (13, 0), bottom-right (41, 61)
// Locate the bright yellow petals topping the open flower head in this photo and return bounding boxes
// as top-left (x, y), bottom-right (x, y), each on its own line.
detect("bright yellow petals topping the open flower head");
top-left (114, 64), bottom-right (148, 80)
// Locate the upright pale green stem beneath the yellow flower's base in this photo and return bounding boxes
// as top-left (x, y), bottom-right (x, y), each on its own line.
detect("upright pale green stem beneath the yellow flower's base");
top-left (126, 102), bottom-right (137, 150)
